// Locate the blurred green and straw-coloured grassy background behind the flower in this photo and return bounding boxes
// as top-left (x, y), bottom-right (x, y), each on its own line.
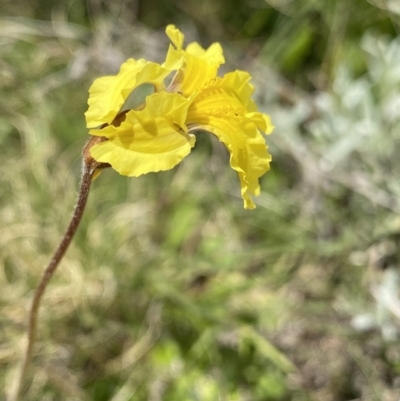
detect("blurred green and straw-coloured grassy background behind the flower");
top-left (0, 0), bottom-right (400, 401)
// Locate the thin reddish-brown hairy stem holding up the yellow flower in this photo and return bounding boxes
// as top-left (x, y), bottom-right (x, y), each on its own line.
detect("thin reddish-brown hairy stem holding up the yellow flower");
top-left (10, 149), bottom-right (103, 401)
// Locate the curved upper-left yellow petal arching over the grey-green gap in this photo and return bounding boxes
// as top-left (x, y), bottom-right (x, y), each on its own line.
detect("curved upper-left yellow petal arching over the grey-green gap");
top-left (85, 59), bottom-right (169, 128)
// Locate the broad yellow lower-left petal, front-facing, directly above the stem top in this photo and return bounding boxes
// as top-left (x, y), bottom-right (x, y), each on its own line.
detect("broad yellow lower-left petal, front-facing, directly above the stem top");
top-left (90, 92), bottom-right (195, 177)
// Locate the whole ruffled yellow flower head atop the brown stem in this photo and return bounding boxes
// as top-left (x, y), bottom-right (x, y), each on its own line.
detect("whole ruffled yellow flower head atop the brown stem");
top-left (85, 25), bottom-right (273, 209)
